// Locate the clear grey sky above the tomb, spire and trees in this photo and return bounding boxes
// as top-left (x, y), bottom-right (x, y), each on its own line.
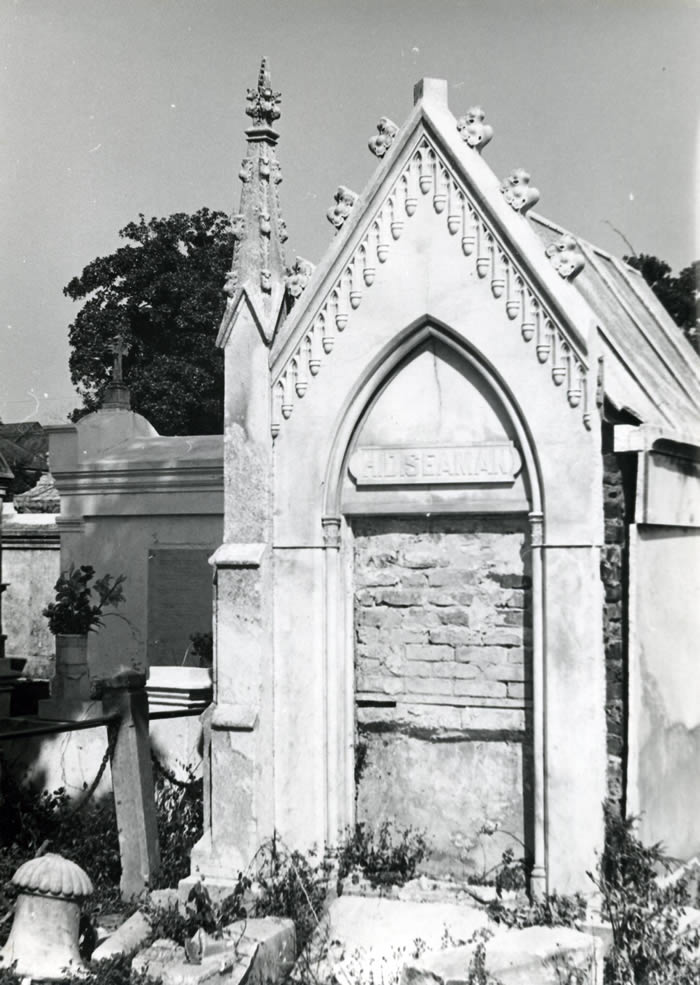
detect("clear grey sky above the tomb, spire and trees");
top-left (0, 0), bottom-right (700, 422)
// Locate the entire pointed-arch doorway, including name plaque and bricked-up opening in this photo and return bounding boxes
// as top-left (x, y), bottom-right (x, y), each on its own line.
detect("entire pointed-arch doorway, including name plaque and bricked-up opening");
top-left (324, 323), bottom-right (544, 877)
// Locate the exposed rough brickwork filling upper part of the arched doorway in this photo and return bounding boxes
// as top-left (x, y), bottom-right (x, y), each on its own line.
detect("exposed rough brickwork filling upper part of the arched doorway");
top-left (354, 517), bottom-right (530, 731)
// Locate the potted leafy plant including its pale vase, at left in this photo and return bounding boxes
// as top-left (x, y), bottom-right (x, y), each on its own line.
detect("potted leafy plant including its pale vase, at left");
top-left (43, 564), bottom-right (126, 701)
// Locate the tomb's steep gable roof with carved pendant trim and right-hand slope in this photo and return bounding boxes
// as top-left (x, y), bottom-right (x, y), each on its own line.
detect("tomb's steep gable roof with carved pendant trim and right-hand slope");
top-left (270, 79), bottom-right (700, 439)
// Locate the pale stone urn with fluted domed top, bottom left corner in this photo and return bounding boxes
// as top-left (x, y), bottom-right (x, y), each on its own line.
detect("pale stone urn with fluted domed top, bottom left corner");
top-left (0, 853), bottom-right (92, 981)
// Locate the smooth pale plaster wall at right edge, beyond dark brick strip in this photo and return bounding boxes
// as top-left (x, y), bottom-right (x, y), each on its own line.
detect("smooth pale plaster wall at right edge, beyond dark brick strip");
top-left (628, 525), bottom-right (700, 860)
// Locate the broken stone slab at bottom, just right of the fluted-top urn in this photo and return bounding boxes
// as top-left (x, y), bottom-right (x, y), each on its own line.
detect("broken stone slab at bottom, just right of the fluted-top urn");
top-left (132, 917), bottom-right (296, 985)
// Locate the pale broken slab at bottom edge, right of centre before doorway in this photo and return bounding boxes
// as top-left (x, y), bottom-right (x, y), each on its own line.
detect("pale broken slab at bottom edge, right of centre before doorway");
top-left (401, 927), bottom-right (603, 985)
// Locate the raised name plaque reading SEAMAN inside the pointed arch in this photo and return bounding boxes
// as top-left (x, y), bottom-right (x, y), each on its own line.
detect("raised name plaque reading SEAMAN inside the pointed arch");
top-left (349, 441), bottom-right (521, 486)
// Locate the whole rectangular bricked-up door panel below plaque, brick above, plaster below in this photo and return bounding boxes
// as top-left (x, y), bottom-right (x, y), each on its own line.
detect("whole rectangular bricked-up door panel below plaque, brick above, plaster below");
top-left (354, 517), bottom-right (530, 874)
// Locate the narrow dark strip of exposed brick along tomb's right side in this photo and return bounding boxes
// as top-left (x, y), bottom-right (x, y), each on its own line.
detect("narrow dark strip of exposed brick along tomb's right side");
top-left (601, 451), bottom-right (628, 807)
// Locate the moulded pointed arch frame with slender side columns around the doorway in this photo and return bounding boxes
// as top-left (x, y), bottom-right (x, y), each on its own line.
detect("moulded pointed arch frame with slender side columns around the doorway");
top-left (322, 315), bottom-right (547, 892)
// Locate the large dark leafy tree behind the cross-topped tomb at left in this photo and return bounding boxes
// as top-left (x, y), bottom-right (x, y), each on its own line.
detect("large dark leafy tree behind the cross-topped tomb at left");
top-left (63, 208), bottom-right (233, 434)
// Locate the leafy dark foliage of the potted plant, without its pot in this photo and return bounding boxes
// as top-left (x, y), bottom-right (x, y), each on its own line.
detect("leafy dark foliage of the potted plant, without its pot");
top-left (42, 564), bottom-right (126, 636)
